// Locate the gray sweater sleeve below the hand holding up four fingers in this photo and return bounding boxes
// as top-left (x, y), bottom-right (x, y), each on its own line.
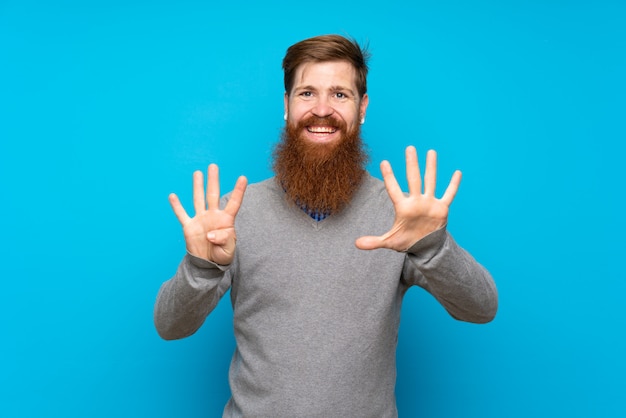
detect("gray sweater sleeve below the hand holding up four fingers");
top-left (154, 254), bottom-right (231, 340)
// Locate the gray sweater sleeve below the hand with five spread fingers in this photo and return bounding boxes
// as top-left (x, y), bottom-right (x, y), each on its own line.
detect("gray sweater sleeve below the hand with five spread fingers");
top-left (403, 227), bottom-right (498, 323)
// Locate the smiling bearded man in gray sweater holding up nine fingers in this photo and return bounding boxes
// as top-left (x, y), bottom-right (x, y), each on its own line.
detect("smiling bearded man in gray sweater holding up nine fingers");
top-left (155, 35), bottom-right (497, 417)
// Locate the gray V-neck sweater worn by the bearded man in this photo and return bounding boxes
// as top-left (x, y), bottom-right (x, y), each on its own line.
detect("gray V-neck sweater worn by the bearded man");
top-left (155, 176), bottom-right (497, 418)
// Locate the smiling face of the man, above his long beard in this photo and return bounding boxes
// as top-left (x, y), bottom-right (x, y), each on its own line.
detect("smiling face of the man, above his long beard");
top-left (285, 61), bottom-right (369, 144)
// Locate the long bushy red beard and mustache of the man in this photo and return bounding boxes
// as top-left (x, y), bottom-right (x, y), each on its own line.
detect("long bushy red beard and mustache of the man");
top-left (273, 118), bottom-right (368, 213)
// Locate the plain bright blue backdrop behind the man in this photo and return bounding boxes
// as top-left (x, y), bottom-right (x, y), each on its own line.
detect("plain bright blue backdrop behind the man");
top-left (0, 0), bottom-right (626, 417)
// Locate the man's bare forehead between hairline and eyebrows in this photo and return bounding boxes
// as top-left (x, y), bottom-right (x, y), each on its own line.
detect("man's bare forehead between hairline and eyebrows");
top-left (294, 61), bottom-right (356, 89)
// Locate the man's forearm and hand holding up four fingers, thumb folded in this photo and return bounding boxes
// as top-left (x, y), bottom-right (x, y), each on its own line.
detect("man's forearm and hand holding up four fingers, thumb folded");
top-left (154, 164), bottom-right (247, 339)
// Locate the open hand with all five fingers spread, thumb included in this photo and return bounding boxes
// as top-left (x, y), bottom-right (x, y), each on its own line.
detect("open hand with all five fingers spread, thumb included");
top-left (356, 146), bottom-right (461, 251)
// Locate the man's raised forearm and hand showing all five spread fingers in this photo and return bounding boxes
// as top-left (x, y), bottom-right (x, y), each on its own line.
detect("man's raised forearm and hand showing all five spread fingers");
top-left (356, 147), bottom-right (498, 322)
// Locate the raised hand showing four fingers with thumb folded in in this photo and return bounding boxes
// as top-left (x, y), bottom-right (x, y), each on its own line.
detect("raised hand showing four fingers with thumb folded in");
top-left (169, 164), bottom-right (248, 265)
